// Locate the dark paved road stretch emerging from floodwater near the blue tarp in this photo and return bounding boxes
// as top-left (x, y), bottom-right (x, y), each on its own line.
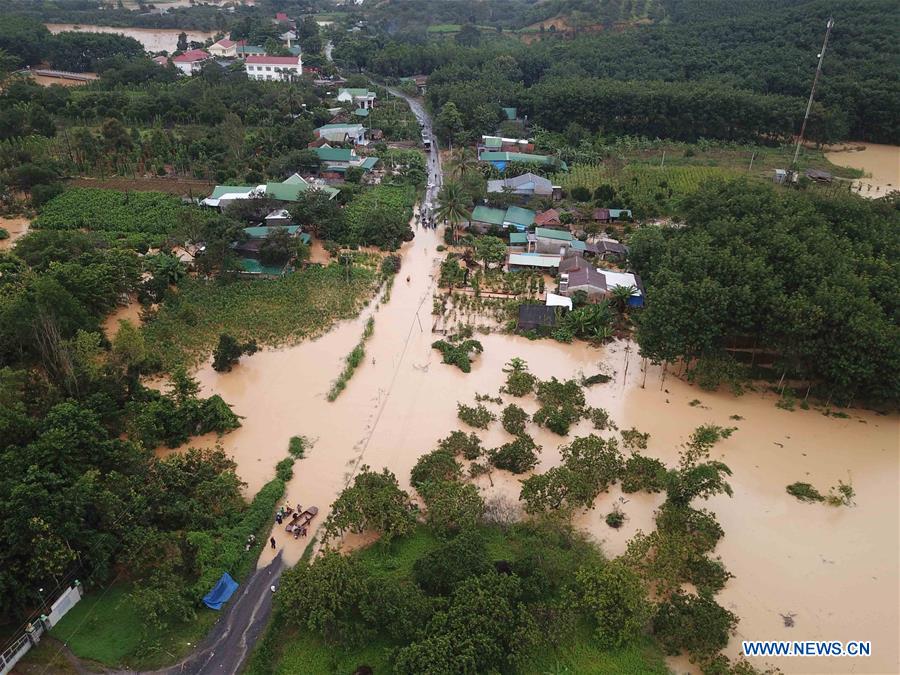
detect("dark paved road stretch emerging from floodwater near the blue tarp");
top-left (139, 552), bottom-right (284, 675)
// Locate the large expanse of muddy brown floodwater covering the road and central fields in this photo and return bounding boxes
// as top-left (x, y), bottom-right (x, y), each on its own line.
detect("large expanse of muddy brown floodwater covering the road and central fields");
top-left (163, 218), bottom-right (900, 673)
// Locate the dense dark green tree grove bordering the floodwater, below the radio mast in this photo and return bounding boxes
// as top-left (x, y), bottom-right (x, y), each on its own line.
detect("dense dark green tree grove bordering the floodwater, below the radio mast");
top-left (630, 181), bottom-right (900, 407)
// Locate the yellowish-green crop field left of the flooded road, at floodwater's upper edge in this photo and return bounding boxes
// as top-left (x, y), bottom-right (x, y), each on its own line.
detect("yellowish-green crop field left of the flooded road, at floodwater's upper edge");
top-left (143, 265), bottom-right (377, 370)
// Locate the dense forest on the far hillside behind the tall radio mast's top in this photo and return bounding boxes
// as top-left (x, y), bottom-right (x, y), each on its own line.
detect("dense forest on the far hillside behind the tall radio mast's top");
top-left (335, 0), bottom-right (900, 143)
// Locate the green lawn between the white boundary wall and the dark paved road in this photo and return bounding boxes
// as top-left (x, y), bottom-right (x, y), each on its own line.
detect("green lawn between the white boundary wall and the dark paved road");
top-left (50, 584), bottom-right (218, 669)
